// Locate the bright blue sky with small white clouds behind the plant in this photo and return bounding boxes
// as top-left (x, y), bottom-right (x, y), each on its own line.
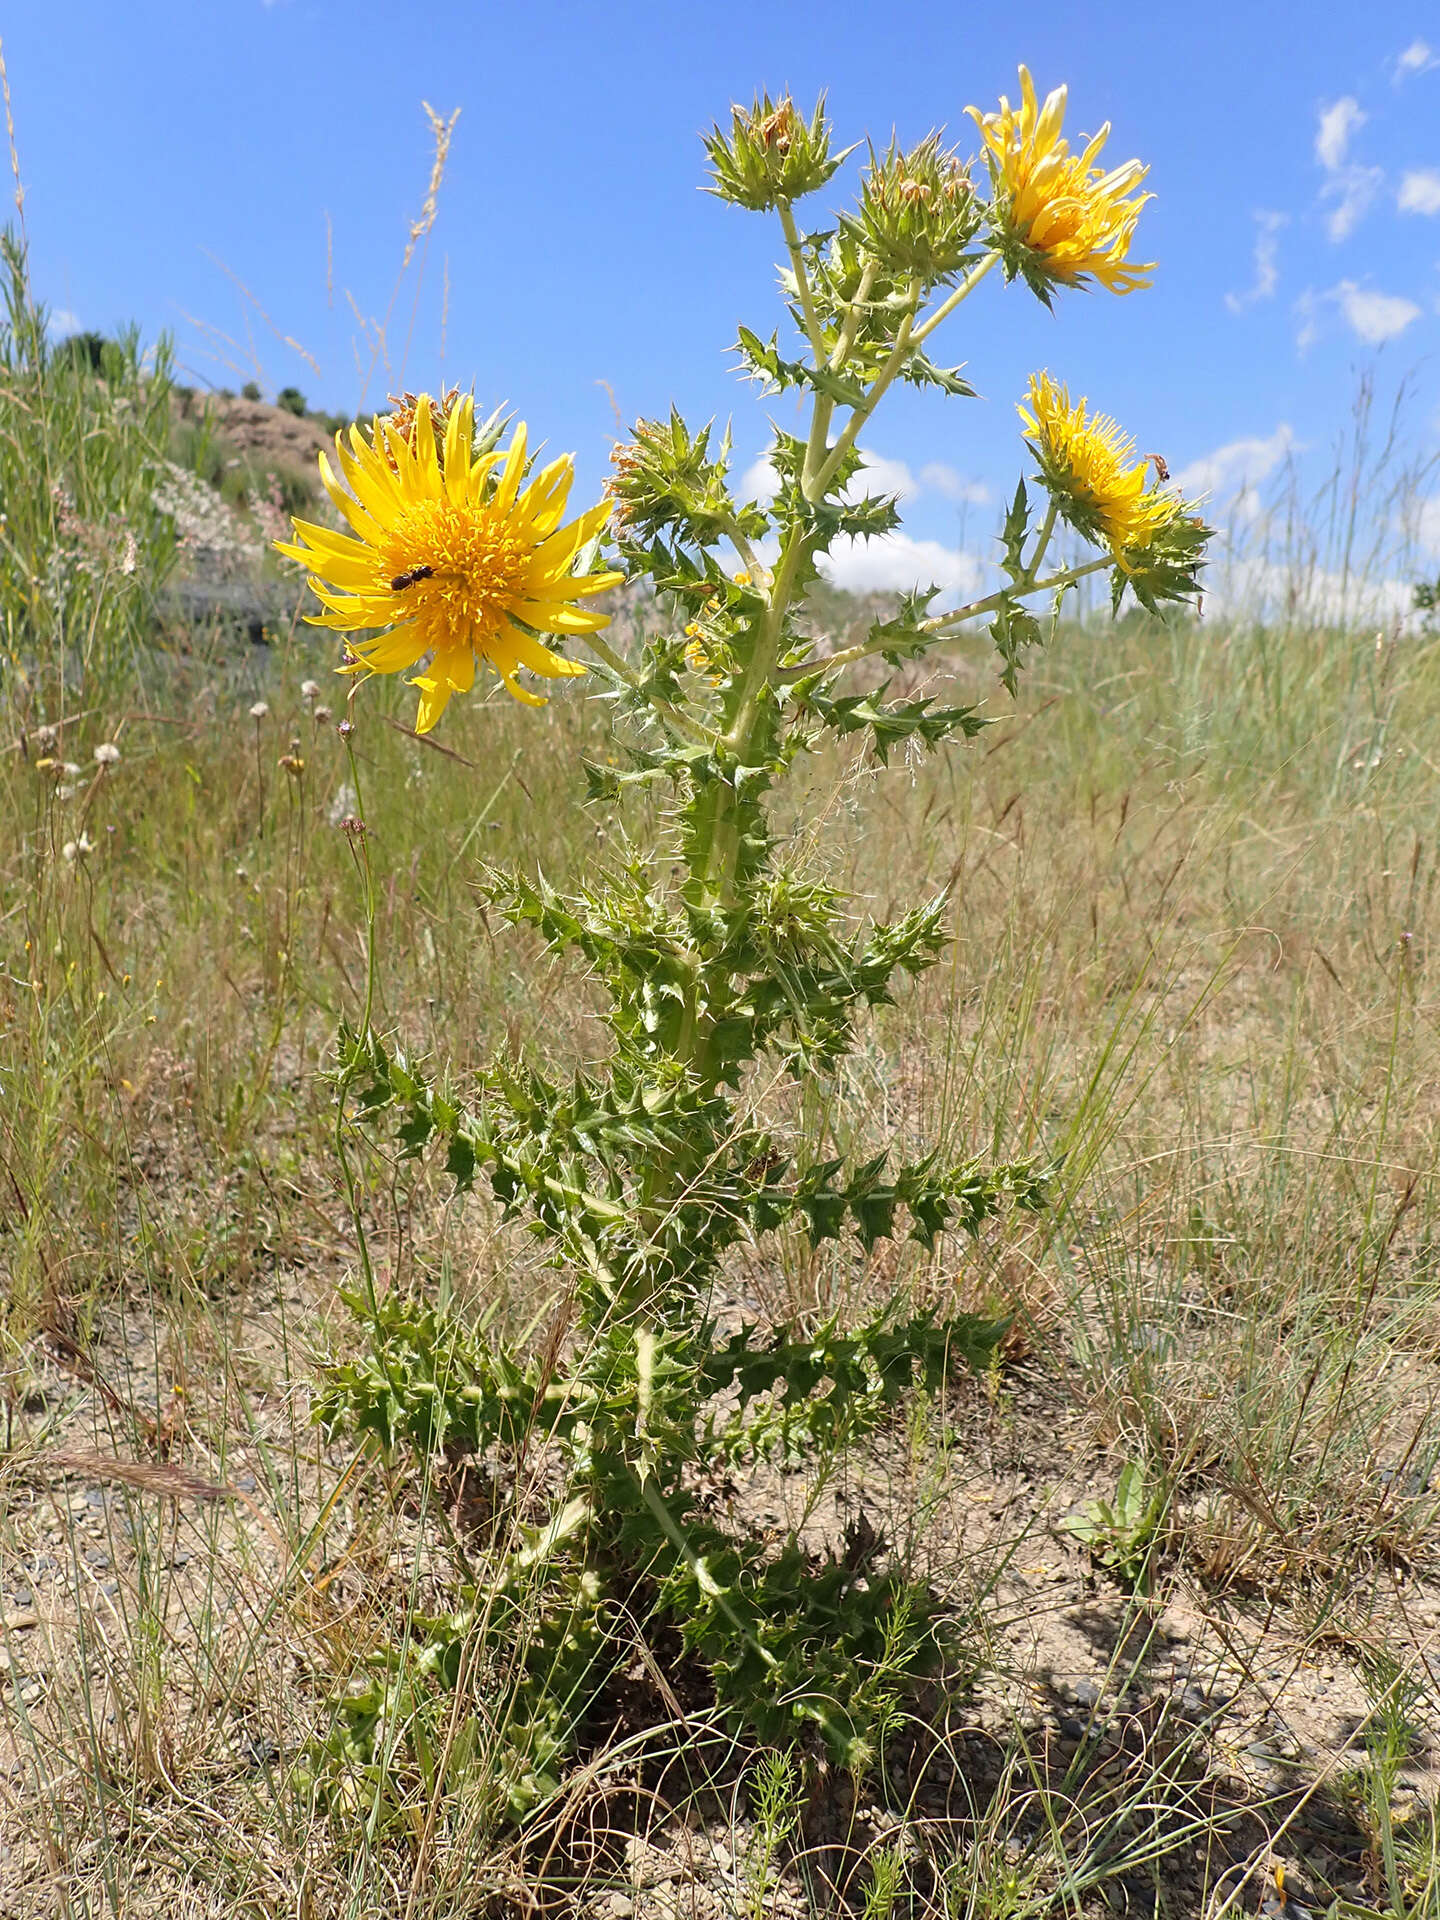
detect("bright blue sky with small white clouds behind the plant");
top-left (4, 0), bottom-right (1440, 606)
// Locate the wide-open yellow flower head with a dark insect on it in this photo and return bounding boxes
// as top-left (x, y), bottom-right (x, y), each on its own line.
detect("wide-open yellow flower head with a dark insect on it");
top-left (276, 394), bottom-right (624, 733)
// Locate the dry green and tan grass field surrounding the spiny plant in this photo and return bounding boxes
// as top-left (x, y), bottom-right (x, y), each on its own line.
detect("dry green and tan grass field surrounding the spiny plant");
top-left (0, 572), bottom-right (1440, 1920)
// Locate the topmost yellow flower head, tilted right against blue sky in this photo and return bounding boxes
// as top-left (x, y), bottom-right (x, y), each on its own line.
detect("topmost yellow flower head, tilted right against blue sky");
top-left (966, 67), bottom-right (1154, 294)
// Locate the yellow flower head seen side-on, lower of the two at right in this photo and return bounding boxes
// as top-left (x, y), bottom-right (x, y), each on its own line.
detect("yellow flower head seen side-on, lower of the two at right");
top-left (1020, 372), bottom-right (1185, 564)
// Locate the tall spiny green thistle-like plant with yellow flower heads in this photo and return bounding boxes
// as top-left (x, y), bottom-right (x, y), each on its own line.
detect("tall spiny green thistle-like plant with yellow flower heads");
top-left (294, 71), bottom-right (1206, 1812)
